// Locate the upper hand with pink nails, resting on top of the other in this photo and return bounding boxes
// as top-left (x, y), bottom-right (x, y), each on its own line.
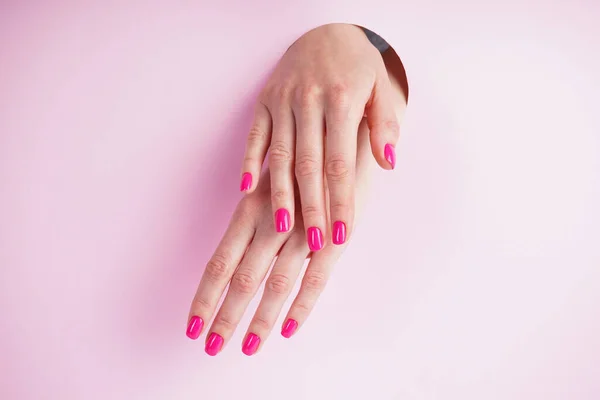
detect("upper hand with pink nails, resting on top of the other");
top-left (241, 24), bottom-right (399, 251)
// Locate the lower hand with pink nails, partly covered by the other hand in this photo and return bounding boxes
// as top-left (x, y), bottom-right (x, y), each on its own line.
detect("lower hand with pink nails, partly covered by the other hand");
top-left (187, 117), bottom-right (372, 356)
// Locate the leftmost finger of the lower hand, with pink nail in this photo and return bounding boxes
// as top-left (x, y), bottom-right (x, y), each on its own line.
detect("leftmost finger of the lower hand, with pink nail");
top-left (187, 206), bottom-right (256, 340)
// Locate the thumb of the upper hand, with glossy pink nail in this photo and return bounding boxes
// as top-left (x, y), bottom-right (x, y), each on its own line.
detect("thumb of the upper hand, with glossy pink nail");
top-left (367, 73), bottom-right (400, 169)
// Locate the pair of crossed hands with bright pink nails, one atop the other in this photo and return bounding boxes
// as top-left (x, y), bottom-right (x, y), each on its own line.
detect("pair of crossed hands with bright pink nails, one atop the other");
top-left (187, 24), bottom-right (405, 356)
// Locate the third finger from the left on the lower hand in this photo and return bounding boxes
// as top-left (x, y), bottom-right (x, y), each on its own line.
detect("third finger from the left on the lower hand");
top-left (242, 234), bottom-right (310, 356)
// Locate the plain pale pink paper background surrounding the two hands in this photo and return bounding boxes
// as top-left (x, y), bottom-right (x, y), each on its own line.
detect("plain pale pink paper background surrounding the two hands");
top-left (0, 0), bottom-right (600, 400)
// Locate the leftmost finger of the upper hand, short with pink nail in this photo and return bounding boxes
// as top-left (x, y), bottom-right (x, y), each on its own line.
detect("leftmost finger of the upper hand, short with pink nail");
top-left (240, 101), bottom-right (271, 193)
